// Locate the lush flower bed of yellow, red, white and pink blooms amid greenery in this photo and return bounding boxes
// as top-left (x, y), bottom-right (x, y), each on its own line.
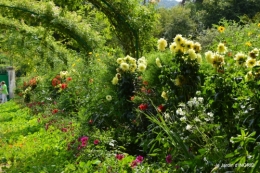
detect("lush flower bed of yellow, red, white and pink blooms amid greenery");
top-left (0, 0), bottom-right (260, 173)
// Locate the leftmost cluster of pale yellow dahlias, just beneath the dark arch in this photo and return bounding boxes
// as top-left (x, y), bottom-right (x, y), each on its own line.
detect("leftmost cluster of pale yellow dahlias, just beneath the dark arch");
top-left (112, 55), bottom-right (147, 85)
